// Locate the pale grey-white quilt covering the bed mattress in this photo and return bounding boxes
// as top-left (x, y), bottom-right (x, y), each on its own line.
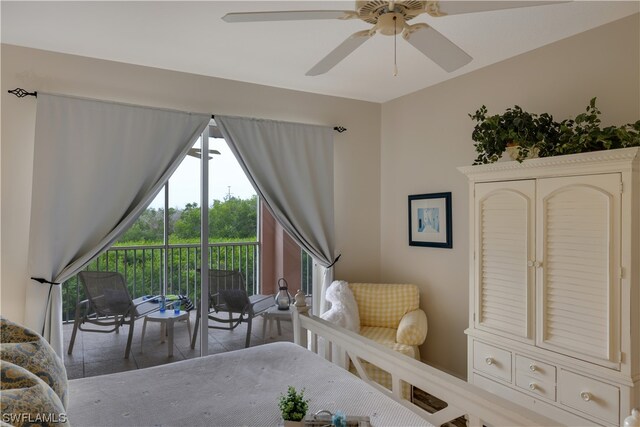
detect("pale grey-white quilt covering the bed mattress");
top-left (67, 343), bottom-right (429, 427)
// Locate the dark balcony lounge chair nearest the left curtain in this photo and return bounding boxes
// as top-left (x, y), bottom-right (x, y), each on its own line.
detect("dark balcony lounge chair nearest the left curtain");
top-left (67, 271), bottom-right (160, 359)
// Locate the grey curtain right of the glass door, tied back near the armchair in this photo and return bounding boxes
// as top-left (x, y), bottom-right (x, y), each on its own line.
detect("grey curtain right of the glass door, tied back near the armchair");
top-left (215, 115), bottom-right (335, 313)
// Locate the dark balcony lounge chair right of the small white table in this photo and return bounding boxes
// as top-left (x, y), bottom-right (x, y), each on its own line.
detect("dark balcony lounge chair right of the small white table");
top-left (191, 270), bottom-right (275, 348)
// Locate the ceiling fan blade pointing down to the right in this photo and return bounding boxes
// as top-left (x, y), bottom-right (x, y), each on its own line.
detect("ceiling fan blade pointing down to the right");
top-left (402, 23), bottom-right (473, 72)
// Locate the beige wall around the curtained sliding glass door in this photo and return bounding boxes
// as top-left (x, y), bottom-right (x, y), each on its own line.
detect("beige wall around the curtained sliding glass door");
top-left (0, 45), bottom-right (381, 322)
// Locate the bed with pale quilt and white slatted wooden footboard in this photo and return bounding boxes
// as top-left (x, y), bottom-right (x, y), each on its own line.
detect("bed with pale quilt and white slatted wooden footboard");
top-left (67, 308), bottom-right (554, 426)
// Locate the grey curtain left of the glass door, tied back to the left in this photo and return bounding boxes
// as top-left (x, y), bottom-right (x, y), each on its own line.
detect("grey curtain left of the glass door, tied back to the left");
top-left (25, 92), bottom-right (211, 357)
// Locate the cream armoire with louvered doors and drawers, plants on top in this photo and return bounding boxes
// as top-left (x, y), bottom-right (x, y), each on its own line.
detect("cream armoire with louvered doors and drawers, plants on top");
top-left (459, 148), bottom-right (640, 425)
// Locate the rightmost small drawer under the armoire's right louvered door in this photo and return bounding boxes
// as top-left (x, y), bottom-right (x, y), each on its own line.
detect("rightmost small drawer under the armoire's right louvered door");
top-left (558, 369), bottom-right (620, 425)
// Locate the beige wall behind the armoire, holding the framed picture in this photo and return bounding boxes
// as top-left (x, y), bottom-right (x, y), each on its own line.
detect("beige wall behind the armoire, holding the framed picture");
top-left (381, 14), bottom-right (640, 376)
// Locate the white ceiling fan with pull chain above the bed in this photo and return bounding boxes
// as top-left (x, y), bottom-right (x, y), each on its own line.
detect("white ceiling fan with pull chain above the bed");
top-left (222, 0), bottom-right (564, 76)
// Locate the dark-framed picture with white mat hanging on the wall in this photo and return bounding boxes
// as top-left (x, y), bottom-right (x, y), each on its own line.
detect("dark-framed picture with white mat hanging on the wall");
top-left (409, 192), bottom-right (453, 248)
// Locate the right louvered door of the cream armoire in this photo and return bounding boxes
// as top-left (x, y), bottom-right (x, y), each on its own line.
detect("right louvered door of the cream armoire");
top-left (536, 174), bottom-right (621, 367)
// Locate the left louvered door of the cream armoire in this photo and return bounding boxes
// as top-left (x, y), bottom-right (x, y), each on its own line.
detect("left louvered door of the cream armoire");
top-left (475, 180), bottom-right (535, 341)
